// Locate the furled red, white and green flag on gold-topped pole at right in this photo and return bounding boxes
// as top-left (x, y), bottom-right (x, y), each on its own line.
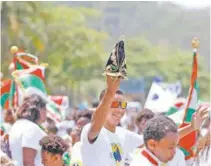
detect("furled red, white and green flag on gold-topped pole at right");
top-left (179, 39), bottom-right (199, 160)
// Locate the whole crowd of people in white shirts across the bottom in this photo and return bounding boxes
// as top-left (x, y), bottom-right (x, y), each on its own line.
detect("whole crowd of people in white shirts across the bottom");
top-left (1, 76), bottom-right (210, 166)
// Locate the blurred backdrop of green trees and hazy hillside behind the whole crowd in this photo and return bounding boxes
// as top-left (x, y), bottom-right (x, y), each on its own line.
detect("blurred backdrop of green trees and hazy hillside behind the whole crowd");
top-left (1, 1), bottom-right (210, 105)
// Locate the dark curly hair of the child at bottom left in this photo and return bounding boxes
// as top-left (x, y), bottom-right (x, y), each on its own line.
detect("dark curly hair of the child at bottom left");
top-left (40, 135), bottom-right (69, 155)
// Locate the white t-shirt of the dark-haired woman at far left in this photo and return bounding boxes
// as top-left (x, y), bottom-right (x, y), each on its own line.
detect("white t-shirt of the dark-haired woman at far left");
top-left (9, 119), bottom-right (46, 166)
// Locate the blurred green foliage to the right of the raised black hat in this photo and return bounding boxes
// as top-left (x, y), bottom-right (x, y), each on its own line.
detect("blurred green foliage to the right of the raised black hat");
top-left (126, 37), bottom-right (210, 100)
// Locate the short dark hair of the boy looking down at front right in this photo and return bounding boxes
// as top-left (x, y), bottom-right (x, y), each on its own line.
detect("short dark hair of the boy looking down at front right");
top-left (143, 115), bottom-right (178, 146)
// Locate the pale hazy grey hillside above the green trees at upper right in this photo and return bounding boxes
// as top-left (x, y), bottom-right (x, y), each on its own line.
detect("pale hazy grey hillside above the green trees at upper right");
top-left (64, 1), bottom-right (210, 71)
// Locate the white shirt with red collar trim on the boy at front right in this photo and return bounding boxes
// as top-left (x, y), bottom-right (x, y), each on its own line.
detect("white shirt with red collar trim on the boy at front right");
top-left (130, 148), bottom-right (186, 166)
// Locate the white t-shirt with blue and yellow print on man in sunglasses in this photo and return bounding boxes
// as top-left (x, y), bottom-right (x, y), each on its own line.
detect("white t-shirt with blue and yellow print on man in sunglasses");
top-left (81, 124), bottom-right (143, 166)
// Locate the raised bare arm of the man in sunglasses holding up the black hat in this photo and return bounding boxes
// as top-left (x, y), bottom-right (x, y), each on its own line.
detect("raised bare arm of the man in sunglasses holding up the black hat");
top-left (88, 76), bottom-right (120, 143)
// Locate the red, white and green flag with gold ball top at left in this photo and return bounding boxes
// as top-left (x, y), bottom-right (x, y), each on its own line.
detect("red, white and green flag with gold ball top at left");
top-left (11, 46), bottom-right (62, 123)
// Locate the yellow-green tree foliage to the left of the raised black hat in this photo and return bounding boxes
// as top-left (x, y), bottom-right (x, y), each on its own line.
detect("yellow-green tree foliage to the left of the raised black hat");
top-left (2, 2), bottom-right (107, 96)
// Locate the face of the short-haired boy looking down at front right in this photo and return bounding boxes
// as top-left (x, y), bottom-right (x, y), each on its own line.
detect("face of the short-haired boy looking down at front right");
top-left (148, 132), bottom-right (179, 163)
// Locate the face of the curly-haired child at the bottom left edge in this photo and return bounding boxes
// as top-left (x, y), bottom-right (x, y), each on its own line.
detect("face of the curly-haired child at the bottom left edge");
top-left (42, 150), bottom-right (63, 166)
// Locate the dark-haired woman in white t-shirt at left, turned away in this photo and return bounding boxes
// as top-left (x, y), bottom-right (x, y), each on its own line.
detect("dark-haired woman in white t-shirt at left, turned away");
top-left (9, 94), bottom-right (46, 166)
